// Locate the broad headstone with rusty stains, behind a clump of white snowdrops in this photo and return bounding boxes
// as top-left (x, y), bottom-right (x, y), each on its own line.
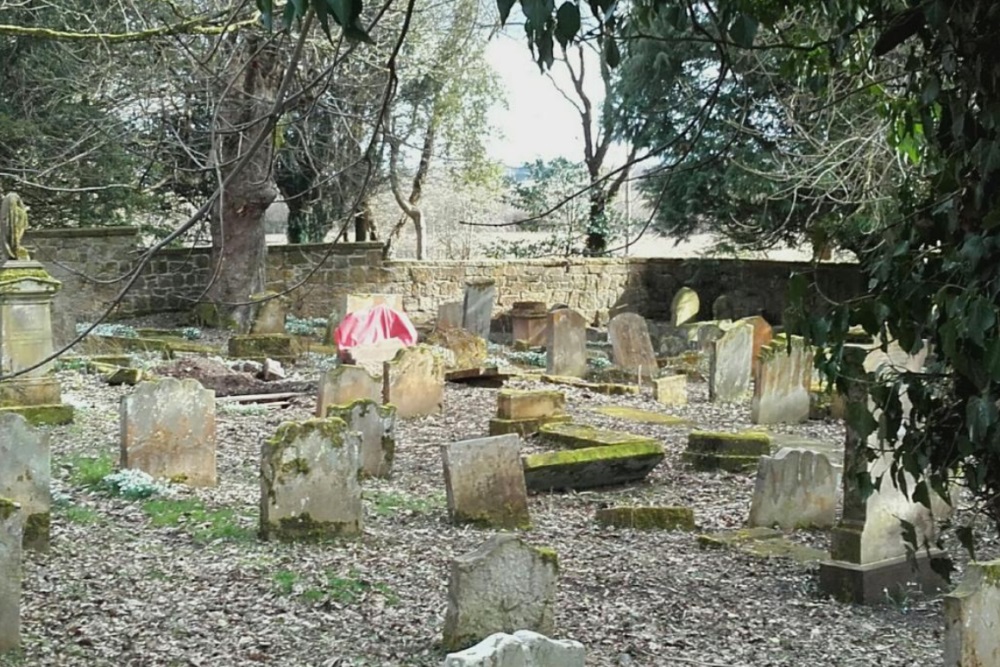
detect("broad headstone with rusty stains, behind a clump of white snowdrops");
top-left (121, 377), bottom-right (216, 486)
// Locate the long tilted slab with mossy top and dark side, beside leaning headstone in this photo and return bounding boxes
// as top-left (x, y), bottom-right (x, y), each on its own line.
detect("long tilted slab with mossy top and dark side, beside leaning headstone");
top-left (522, 442), bottom-right (664, 493)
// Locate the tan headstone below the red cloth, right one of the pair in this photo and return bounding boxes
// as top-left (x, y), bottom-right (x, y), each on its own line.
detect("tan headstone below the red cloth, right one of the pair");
top-left (382, 345), bottom-right (444, 419)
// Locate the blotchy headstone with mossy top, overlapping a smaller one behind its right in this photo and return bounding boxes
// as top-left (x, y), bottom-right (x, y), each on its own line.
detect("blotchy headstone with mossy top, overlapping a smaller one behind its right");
top-left (260, 418), bottom-right (362, 541)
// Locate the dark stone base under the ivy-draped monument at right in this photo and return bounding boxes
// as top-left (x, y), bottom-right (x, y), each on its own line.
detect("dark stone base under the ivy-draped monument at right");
top-left (819, 549), bottom-right (948, 604)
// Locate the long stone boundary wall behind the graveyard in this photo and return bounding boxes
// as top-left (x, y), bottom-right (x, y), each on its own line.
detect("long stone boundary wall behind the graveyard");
top-left (25, 227), bottom-right (864, 342)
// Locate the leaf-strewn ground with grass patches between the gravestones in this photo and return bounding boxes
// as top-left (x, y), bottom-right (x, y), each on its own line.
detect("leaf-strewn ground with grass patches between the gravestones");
top-left (9, 344), bottom-right (960, 667)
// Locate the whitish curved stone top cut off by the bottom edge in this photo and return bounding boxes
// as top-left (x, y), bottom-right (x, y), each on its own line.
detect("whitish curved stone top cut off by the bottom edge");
top-left (443, 630), bottom-right (587, 667)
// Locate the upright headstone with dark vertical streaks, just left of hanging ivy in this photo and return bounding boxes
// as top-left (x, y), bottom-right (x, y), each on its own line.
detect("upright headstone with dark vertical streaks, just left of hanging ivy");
top-left (750, 336), bottom-right (813, 424)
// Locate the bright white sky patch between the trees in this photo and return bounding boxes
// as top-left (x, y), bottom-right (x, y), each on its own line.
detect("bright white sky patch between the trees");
top-left (486, 23), bottom-right (624, 167)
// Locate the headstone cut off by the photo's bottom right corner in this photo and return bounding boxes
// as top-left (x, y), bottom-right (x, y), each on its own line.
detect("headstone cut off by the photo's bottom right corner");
top-left (940, 560), bottom-right (1000, 667)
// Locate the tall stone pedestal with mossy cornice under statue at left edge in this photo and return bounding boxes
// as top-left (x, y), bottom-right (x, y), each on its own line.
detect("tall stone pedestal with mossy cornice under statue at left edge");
top-left (0, 261), bottom-right (73, 424)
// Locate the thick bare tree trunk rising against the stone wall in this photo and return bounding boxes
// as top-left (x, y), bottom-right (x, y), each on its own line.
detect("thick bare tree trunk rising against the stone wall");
top-left (208, 37), bottom-right (279, 333)
